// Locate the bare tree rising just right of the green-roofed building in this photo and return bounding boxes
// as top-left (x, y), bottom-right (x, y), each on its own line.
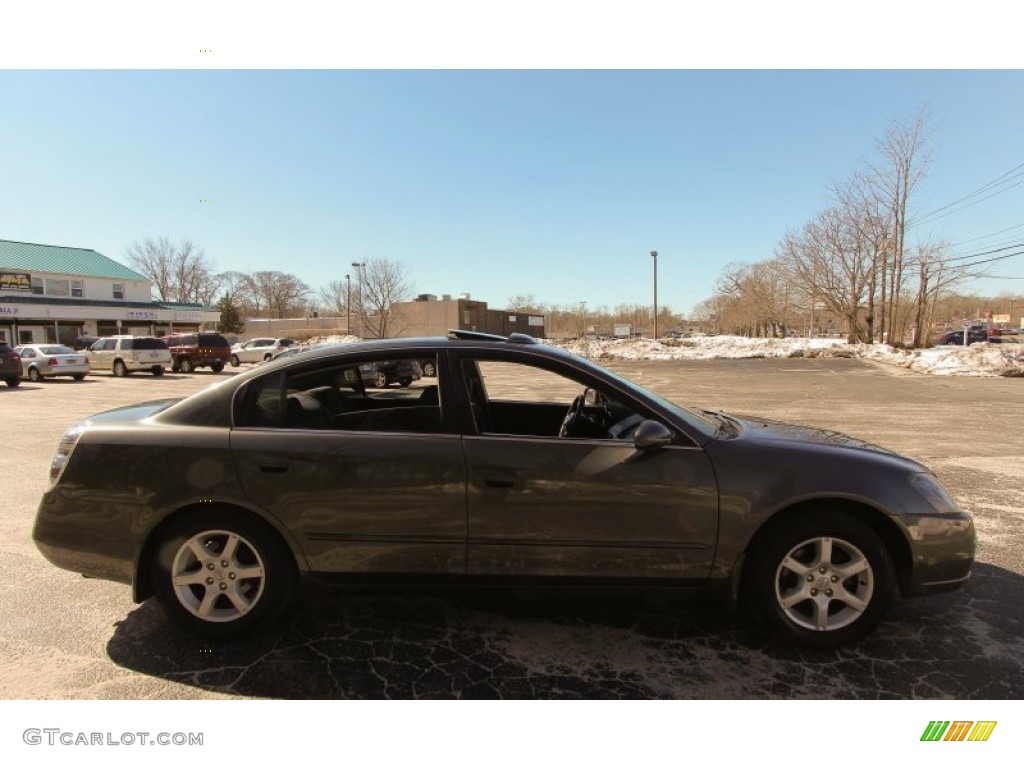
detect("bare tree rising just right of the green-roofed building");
top-left (125, 237), bottom-right (220, 306)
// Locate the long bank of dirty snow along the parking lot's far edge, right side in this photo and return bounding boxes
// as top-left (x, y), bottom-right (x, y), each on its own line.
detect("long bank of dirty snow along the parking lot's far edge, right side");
top-left (548, 336), bottom-right (1024, 377)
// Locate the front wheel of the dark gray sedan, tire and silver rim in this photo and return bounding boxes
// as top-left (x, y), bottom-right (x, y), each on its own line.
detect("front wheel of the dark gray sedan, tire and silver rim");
top-left (744, 508), bottom-right (895, 648)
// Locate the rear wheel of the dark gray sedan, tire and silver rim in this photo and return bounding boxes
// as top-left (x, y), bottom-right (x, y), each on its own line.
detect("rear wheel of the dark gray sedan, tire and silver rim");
top-left (152, 508), bottom-right (298, 637)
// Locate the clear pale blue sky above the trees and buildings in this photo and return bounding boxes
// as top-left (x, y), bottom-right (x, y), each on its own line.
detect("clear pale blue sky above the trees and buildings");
top-left (0, 70), bottom-right (1024, 312)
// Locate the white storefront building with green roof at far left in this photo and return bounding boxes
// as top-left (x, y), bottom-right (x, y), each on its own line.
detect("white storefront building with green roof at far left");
top-left (0, 234), bottom-right (219, 344)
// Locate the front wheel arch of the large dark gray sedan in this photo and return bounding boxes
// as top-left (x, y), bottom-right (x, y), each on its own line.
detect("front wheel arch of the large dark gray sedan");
top-left (732, 497), bottom-right (913, 600)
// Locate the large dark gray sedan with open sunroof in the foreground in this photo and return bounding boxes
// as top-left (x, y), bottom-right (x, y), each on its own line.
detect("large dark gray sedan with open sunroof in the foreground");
top-left (34, 332), bottom-right (975, 646)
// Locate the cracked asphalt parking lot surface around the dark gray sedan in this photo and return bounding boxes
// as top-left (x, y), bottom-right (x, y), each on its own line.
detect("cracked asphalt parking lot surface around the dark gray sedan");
top-left (0, 358), bottom-right (1024, 699)
